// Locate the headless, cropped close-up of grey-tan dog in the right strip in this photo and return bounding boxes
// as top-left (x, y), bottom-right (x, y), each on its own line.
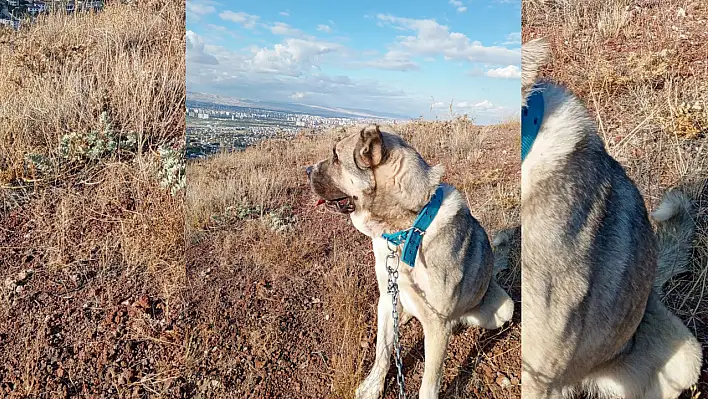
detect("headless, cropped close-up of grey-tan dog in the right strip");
top-left (521, 39), bottom-right (702, 399)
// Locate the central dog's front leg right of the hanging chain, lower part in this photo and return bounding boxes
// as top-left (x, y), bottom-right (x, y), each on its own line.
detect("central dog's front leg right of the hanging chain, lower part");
top-left (419, 316), bottom-right (450, 399)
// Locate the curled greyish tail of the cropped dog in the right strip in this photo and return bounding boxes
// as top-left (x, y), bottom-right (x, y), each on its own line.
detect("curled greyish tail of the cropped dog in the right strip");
top-left (651, 189), bottom-right (696, 294)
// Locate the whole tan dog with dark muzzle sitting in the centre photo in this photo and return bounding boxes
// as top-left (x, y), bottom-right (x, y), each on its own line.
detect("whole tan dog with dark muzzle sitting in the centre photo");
top-left (307, 125), bottom-right (514, 399)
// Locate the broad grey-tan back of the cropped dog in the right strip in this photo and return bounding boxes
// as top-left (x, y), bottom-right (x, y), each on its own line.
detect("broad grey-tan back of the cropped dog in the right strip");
top-left (522, 79), bottom-right (656, 390)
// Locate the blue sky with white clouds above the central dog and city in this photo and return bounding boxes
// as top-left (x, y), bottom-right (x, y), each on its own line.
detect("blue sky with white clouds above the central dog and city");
top-left (187, 0), bottom-right (521, 123)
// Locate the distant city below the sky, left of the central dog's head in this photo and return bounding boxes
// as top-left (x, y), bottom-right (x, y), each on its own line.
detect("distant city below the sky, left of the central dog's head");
top-left (187, 100), bottom-right (402, 159)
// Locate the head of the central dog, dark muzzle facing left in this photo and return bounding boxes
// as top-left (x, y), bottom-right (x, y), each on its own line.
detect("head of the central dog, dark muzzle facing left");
top-left (307, 125), bottom-right (443, 225)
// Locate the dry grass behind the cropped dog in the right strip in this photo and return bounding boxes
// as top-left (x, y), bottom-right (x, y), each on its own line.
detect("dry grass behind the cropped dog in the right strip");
top-left (522, 0), bottom-right (708, 395)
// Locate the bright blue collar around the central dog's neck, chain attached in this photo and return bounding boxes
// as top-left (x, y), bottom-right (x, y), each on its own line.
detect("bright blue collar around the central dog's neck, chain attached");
top-left (382, 186), bottom-right (443, 267)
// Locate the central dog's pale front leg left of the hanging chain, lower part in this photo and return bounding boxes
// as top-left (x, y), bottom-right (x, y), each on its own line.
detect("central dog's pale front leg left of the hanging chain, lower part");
top-left (356, 293), bottom-right (401, 399)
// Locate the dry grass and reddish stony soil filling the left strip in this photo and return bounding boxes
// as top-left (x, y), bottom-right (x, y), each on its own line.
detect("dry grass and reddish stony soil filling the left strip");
top-left (0, 0), bottom-right (186, 397)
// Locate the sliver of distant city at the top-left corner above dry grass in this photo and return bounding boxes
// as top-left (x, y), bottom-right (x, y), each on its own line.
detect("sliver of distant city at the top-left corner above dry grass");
top-left (0, 0), bottom-right (103, 29)
